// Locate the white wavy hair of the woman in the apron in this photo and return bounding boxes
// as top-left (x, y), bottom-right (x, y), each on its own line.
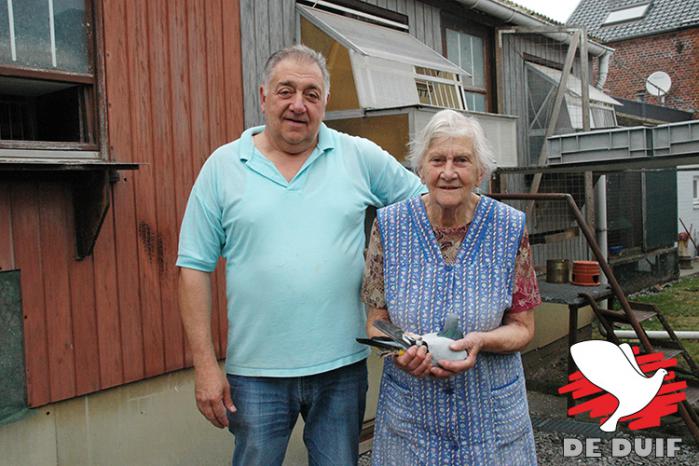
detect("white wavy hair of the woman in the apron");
top-left (408, 110), bottom-right (495, 178)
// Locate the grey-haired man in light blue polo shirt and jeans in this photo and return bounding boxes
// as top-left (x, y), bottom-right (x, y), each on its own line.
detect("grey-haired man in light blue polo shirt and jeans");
top-left (177, 45), bottom-right (423, 465)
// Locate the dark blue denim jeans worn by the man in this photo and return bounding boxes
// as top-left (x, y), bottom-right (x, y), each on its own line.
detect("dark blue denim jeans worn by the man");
top-left (228, 361), bottom-right (367, 466)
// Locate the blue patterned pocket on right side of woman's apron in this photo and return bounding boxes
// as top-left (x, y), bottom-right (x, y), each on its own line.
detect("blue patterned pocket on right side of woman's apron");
top-left (490, 376), bottom-right (531, 445)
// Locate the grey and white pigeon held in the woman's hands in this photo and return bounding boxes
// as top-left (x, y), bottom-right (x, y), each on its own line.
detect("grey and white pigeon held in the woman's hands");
top-left (357, 314), bottom-right (468, 365)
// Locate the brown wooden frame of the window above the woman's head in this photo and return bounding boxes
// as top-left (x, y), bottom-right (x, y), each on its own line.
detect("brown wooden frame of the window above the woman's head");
top-left (442, 15), bottom-right (496, 112)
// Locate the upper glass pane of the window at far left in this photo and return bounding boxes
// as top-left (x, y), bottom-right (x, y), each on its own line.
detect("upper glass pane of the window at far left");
top-left (0, 0), bottom-right (91, 73)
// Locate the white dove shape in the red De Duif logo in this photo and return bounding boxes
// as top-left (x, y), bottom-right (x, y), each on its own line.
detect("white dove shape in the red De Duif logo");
top-left (570, 340), bottom-right (667, 432)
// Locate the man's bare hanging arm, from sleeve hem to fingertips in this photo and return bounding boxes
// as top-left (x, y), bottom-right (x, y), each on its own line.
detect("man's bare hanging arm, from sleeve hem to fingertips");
top-left (179, 268), bottom-right (236, 428)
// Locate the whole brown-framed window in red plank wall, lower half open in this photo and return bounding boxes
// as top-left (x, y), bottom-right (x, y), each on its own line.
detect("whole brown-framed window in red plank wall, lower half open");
top-left (0, 0), bottom-right (99, 158)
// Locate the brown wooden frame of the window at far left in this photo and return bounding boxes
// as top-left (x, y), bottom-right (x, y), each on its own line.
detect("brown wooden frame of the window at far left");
top-left (0, 0), bottom-right (106, 160)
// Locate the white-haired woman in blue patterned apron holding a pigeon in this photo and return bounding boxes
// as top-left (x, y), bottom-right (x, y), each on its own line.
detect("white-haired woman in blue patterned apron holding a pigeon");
top-left (362, 110), bottom-right (541, 466)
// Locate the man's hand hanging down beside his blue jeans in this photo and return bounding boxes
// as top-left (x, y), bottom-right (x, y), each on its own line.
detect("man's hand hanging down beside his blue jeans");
top-left (194, 365), bottom-right (236, 428)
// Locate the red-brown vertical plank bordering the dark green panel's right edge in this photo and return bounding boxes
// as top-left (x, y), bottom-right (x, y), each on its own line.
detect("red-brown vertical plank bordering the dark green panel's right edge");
top-left (11, 183), bottom-right (49, 406)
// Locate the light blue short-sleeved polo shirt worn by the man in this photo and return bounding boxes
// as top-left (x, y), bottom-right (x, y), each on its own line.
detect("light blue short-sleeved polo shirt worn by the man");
top-left (177, 124), bottom-right (424, 377)
